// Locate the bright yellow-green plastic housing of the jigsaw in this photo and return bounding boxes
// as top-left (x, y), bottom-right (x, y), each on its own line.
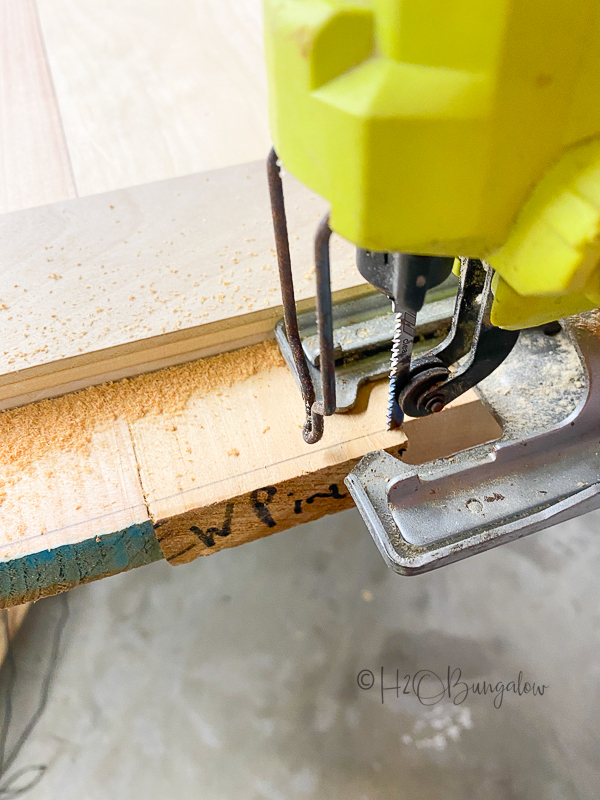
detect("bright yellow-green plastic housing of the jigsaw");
top-left (265, 0), bottom-right (600, 327)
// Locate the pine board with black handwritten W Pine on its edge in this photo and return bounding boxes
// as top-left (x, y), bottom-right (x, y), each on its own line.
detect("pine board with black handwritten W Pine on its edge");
top-left (138, 354), bottom-right (501, 565)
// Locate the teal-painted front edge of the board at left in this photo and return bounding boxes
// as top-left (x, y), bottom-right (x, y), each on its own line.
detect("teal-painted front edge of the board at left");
top-left (0, 520), bottom-right (163, 608)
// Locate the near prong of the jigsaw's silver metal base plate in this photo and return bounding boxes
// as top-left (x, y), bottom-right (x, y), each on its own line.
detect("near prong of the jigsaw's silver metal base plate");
top-left (346, 317), bottom-right (600, 575)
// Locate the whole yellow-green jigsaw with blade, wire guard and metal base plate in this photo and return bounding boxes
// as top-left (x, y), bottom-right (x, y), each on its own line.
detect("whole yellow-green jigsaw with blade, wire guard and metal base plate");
top-left (265, 0), bottom-right (600, 572)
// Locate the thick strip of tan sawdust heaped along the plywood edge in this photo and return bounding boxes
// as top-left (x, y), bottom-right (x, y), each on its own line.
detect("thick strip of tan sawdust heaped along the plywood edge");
top-left (0, 341), bottom-right (285, 475)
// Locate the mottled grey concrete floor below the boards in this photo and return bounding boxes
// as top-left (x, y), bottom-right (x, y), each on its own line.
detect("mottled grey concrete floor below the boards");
top-left (2, 512), bottom-right (600, 800)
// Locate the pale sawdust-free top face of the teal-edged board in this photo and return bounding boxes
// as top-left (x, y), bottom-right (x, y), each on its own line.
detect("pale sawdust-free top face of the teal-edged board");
top-left (0, 424), bottom-right (148, 560)
